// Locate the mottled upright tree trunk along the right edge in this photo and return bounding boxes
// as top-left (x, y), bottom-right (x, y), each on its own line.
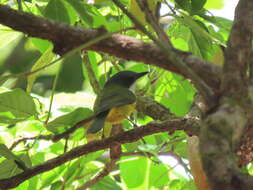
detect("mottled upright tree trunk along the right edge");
top-left (200, 0), bottom-right (253, 190)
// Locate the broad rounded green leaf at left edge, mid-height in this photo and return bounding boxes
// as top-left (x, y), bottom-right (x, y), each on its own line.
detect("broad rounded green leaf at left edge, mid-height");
top-left (0, 89), bottom-right (37, 119)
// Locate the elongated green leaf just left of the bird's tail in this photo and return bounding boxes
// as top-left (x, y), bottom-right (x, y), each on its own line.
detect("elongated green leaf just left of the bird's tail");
top-left (47, 108), bottom-right (93, 134)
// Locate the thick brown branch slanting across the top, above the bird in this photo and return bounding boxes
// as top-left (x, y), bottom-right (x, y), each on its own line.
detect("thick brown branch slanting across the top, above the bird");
top-left (0, 5), bottom-right (221, 92)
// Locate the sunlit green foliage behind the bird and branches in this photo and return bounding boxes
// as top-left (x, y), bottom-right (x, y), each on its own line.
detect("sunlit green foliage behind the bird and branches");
top-left (0, 0), bottom-right (232, 190)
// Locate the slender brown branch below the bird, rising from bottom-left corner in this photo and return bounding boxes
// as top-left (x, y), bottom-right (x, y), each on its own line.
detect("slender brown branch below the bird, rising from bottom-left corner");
top-left (0, 119), bottom-right (199, 190)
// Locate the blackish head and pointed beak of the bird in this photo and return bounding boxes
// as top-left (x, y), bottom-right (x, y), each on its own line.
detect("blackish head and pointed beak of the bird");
top-left (105, 71), bottom-right (148, 88)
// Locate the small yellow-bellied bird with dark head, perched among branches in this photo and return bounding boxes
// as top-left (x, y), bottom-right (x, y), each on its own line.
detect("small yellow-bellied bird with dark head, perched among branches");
top-left (87, 71), bottom-right (148, 134)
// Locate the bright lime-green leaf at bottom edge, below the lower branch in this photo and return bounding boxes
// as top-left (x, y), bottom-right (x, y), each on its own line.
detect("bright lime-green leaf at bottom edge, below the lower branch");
top-left (120, 156), bottom-right (150, 190)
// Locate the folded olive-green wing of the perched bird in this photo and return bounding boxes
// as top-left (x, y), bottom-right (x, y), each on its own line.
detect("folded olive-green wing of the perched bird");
top-left (94, 85), bottom-right (136, 113)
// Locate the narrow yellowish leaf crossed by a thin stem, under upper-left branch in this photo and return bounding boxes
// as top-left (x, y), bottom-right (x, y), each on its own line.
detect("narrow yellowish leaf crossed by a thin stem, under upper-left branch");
top-left (26, 46), bottom-right (55, 93)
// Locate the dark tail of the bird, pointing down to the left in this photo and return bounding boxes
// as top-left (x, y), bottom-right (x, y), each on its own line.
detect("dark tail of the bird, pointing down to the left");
top-left (87, 111), bottom-right (109, 134)
